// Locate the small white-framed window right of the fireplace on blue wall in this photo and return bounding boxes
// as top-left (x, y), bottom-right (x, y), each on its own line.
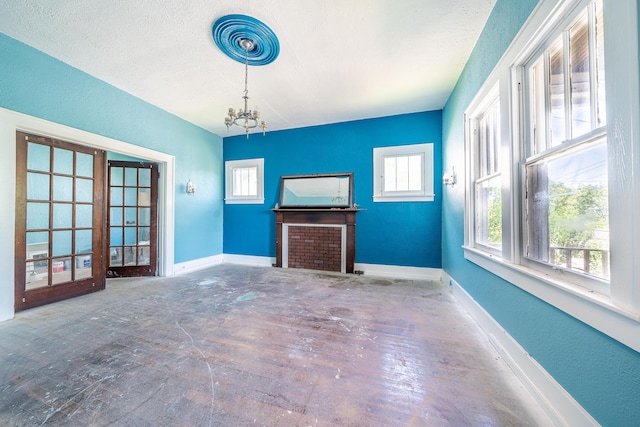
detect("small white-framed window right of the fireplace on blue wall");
top-left (373, 144), bottom-right (434, 202)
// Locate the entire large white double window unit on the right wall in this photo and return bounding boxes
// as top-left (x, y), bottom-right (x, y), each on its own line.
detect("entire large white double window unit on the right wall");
top-left (464, 0), bottom-right (640, 351)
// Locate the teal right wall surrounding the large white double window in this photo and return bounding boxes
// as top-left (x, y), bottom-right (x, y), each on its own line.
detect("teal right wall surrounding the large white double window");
top-left (442, 0), bottom-right (640, 426)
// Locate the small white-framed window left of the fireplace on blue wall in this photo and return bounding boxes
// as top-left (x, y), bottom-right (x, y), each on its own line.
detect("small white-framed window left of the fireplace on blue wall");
top-left (224, 159), bottom-right (264, 204)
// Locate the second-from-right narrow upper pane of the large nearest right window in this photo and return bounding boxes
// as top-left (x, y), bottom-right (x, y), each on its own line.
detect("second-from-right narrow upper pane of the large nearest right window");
top-left (569, 13), bottom-right (591, 138)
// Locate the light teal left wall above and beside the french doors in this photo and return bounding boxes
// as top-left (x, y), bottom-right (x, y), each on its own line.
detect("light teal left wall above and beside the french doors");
top-left (0, 33), bottom-right (223, 263)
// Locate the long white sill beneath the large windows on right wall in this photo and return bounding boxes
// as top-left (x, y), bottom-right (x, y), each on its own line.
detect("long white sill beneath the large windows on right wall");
top-left (463, 246), bottom-right (640, 351)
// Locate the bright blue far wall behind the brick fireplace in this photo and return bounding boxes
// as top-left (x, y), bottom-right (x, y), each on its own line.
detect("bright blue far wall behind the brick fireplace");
top-left (224, 111), bottom-right (442, 268)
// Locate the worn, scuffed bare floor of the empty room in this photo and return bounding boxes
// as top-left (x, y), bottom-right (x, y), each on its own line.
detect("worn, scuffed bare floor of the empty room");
top-left (0, 264), bottom-right (549, 426)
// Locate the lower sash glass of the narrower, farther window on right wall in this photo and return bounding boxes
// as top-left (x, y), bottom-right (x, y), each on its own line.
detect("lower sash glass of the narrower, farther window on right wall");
top-left (475, 175), bottom-right (502, 250)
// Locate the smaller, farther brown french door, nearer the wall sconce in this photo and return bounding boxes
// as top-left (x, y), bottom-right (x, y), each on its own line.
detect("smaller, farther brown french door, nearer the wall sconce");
top-left (107, 160), bottom-right (158, 277)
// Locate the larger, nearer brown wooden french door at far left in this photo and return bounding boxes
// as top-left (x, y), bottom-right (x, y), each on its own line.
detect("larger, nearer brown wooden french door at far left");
top-left (15, 132), bottom-right (106, 311)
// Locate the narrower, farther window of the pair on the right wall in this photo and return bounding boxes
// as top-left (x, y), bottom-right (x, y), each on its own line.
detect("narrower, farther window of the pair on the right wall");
top-left (467, 86), bottom-right (502, 253)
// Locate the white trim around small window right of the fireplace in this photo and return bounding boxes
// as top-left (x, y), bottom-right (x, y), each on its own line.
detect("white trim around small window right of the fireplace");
top-left (373, 143), bottom-right (435, 202)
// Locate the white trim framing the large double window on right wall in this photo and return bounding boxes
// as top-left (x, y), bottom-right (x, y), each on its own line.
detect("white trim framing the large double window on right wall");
top-left (464, 0), bottom-right (640, 351)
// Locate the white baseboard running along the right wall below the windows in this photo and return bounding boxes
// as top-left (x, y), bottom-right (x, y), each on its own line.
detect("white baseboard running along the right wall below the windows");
top-left (442, 272), bottom-right (599, 426)
